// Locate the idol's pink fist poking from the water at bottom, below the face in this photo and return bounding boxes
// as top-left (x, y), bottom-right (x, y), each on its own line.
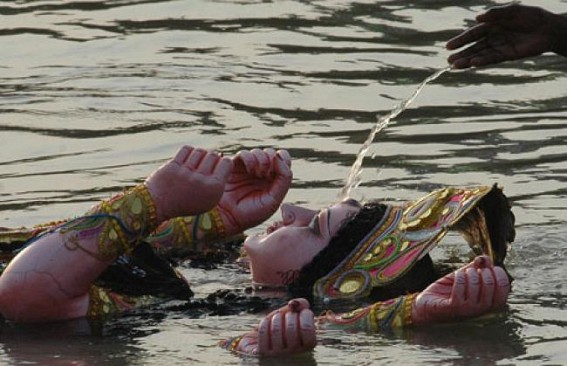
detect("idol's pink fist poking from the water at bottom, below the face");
top-left (221, 298), bottom-right (317, 356)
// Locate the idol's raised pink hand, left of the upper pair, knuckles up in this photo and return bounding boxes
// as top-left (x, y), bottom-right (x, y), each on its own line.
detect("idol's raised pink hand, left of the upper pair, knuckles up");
top-left (149, 146), bottom-right (233, 222)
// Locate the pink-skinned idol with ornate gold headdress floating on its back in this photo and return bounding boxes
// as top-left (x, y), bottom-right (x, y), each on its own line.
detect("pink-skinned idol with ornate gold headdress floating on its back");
top-left (0, 146), bottom-right (514, 355)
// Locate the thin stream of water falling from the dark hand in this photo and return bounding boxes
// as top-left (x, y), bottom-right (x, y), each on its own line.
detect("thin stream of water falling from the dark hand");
top-left (339, 66), bottom-right (451, 199)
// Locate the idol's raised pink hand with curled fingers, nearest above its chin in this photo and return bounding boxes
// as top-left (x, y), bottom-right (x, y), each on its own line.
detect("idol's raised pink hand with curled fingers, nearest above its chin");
top-left (218, 149), bottom-right (292, 235)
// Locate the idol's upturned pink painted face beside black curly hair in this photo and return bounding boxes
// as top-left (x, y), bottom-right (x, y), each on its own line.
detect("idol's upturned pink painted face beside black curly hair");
top-left (244, 199), bottom-right (361, 286)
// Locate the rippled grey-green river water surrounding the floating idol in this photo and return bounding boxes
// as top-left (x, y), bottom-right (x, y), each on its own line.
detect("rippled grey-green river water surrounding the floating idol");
top-left (0, 0), bottom-right (567, 365)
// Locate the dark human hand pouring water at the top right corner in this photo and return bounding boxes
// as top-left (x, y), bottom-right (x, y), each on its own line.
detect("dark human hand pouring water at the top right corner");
top-left (446, 4), bottom-right (567, 69)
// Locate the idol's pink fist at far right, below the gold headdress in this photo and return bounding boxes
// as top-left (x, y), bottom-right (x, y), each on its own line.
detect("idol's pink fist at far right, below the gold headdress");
top-left (412, 256), bottom-right (510, 325)
